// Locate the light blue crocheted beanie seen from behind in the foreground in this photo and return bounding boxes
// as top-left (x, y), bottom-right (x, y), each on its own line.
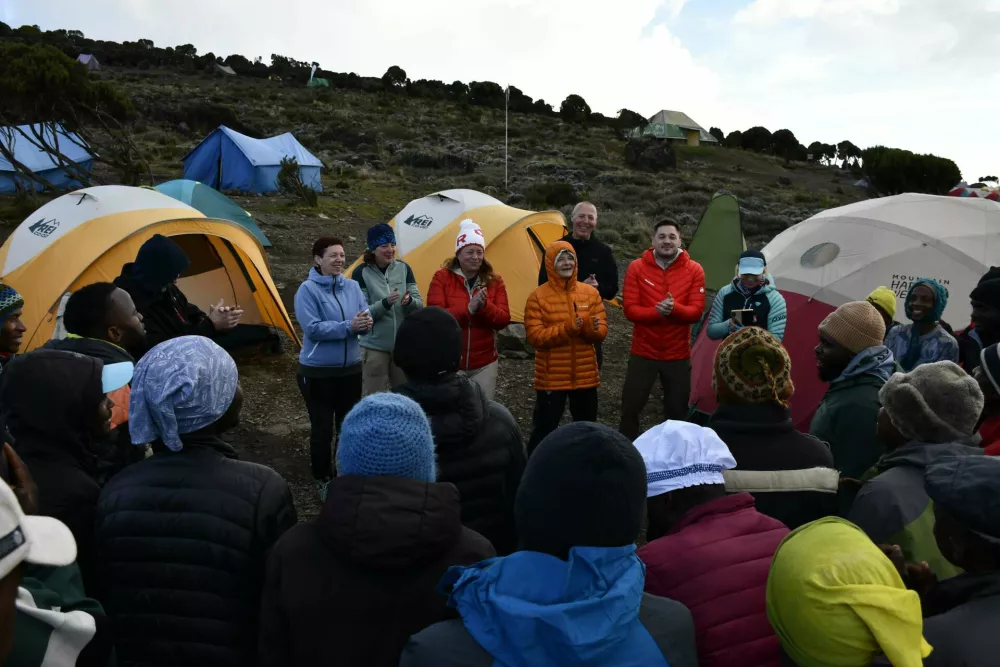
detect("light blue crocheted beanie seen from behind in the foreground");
top-left (337, 392), bottom-right (437, 482)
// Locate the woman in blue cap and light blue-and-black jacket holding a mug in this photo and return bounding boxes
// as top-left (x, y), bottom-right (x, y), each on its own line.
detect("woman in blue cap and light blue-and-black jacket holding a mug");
top-left (706, 250), bottom-right (787, 340)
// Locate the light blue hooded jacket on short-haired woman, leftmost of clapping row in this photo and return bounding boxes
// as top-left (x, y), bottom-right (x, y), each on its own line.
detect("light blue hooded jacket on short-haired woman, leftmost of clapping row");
top-left (295, 267), bottom-right (368, 367)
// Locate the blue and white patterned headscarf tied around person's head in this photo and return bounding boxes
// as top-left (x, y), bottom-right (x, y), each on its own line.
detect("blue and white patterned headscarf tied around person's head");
top-left (128, 336), bottom-right (239, 452)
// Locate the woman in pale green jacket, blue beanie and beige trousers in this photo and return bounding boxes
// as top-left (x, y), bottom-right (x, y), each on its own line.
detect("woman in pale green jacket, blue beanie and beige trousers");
top-left (351, 223), bottom-right (424, 396)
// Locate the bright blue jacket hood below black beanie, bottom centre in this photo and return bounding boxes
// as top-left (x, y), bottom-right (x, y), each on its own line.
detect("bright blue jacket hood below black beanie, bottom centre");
top-left (441, 545), bottom-right (667, 667)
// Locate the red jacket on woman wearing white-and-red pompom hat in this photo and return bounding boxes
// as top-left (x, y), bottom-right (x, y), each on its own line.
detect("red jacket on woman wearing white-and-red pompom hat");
top-left (427, 269), bottom-right (510, 371)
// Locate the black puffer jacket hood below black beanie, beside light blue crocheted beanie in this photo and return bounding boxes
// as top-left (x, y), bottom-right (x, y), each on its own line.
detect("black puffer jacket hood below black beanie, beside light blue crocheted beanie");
top-left (395, 373), bottom-right (489, 451)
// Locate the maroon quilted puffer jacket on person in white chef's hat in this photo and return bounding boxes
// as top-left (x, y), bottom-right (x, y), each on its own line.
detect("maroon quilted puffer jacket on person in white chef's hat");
top-left (639, 493), bottom-right (788, 667)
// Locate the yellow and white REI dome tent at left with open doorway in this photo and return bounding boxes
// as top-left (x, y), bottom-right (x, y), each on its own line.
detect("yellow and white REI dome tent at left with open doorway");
top-left (0, 185), bottom-right (298, 352)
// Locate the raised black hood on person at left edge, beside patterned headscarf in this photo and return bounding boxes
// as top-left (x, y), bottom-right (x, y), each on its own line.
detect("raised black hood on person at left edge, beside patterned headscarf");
top-left (0, 348), bottom-right (104, 462)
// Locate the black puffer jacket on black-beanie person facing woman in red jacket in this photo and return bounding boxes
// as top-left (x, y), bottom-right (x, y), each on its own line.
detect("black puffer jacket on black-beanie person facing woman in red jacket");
top-left (396, 374), bottom-right (527, 556)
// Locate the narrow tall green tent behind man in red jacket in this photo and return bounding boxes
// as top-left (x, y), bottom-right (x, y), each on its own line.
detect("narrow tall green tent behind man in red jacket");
top-left (688, 194), bottom-right (747, 292)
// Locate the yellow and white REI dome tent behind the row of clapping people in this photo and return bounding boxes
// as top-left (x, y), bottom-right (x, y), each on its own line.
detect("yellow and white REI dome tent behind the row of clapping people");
top-left (347, 190), bottom-right (566, 322)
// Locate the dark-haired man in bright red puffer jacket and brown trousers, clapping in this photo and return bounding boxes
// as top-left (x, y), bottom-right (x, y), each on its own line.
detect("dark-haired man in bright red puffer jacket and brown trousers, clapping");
top-left (618, 220), bottom-right (705, 440)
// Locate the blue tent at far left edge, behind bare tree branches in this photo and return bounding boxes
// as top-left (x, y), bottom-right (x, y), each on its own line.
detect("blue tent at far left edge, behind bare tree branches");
top-left (0, 124), bottom-right (94, 194)
